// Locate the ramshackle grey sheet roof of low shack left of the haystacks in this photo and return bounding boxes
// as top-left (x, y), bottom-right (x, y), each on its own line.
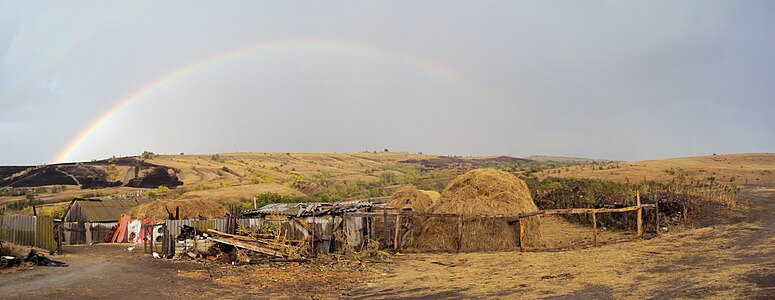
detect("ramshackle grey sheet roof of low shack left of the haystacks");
top-left (242, 200), bottom-right (380, 217)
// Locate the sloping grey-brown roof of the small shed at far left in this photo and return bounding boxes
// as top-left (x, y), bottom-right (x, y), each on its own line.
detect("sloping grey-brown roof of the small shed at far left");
top-left (65, 198), bottom-right (150, 222)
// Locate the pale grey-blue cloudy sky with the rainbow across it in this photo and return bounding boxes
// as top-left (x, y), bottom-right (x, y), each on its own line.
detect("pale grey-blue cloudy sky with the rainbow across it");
top-left (0, 0), bottom-right (775, 165)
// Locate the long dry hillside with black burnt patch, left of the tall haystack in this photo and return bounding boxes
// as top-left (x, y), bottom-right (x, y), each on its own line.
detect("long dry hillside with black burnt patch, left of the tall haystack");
top-left (0, 152), bottom-right (523, 210)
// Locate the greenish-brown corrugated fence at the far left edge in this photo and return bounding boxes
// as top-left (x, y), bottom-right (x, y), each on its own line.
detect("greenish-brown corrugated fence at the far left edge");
top-left (0, 215), bottom-right (57, 250)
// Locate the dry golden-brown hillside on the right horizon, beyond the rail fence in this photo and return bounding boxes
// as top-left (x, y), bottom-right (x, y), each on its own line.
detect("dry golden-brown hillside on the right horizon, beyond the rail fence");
top-left (536, 153), bottom-right (775, 186)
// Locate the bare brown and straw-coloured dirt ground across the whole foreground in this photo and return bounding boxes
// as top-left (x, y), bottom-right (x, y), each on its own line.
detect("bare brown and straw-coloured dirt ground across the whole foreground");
top-left (0, 189), bottom-right (775, 299)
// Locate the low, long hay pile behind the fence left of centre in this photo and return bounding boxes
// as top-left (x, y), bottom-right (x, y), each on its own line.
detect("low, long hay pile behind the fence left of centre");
top-left (131, 199), bottom-right (226, 221)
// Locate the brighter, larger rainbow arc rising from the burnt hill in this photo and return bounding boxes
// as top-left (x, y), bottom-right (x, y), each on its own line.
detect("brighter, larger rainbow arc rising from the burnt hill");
top-left (53, 39), bottom-right (511, 162)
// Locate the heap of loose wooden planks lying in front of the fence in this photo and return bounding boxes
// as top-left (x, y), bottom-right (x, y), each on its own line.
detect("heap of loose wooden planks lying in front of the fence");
top-left (207, 229), bottom-right (303, 258)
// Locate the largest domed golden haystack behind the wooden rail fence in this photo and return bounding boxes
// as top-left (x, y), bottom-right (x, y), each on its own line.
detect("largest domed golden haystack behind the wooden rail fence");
top-left (416, 169), bottom-right (542, 251)
